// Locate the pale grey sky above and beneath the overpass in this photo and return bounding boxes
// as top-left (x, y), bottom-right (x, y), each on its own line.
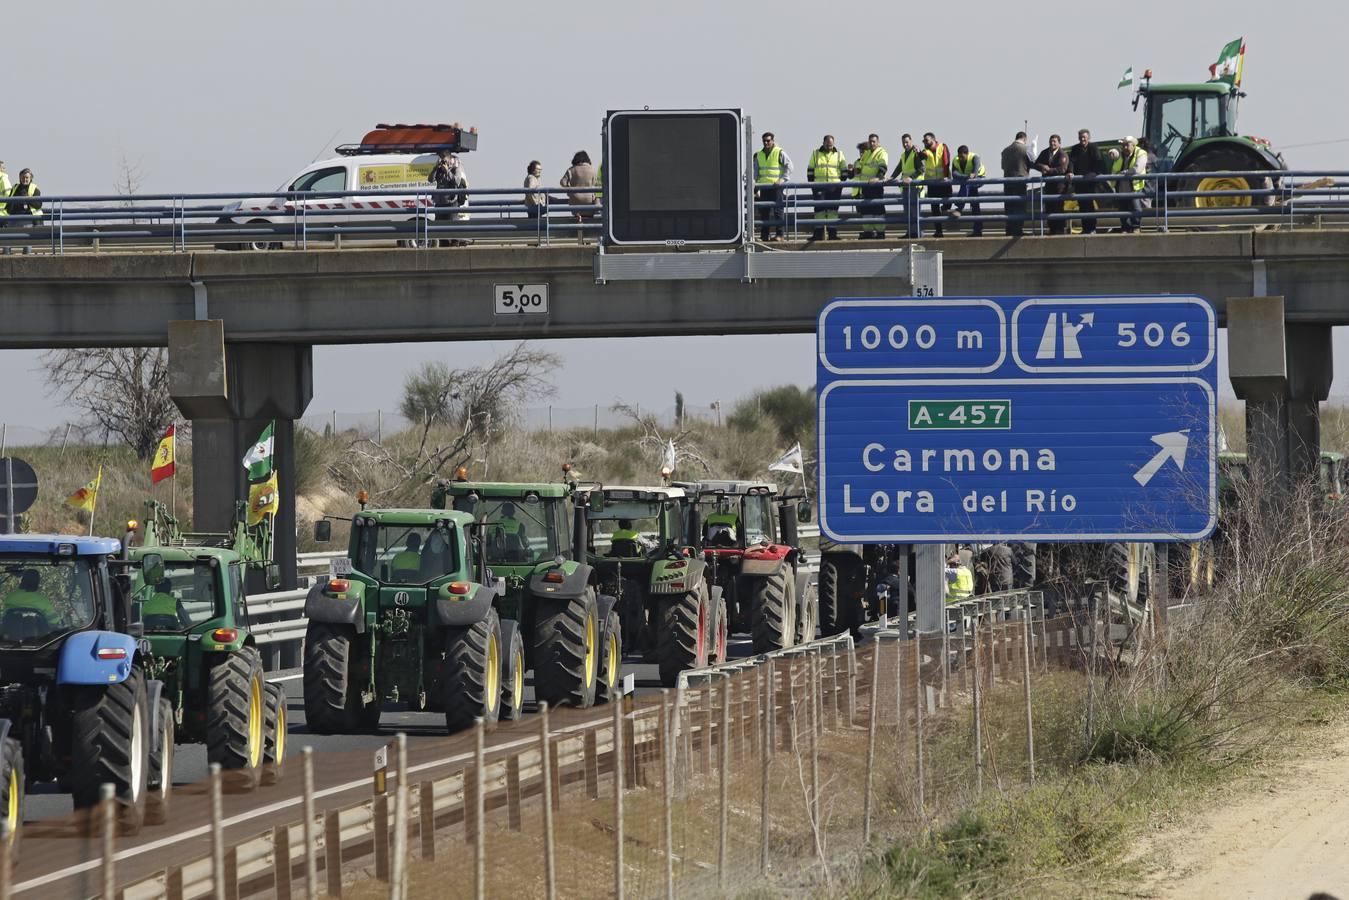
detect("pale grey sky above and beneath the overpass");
top-left (0, 0), bottom-right (1349, 426)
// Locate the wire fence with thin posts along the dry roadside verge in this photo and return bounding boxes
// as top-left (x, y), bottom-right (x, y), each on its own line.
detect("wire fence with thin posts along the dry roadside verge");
top-left (0, 591), bottom-right (1148, 900)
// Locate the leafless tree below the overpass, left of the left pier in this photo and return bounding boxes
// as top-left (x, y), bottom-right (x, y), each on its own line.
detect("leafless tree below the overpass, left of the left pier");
top-left (42, 347), bottom-right (177, 459)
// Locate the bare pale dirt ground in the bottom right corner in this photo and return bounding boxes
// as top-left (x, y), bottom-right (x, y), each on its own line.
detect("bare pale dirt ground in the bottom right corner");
top-left (1144, 725), bottom-right (1349, 900)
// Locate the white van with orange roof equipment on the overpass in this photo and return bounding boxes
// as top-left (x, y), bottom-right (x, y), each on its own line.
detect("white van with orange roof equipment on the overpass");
top-left (217, 123), bottom-right (478, 250)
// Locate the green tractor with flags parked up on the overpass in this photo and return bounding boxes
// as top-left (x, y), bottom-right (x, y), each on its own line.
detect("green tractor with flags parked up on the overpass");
top-left (1122, 70), bottom-right (1287, 209)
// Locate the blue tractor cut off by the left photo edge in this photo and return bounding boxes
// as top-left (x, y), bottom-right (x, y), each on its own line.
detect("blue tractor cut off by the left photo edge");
top-left (0, 534), bottom-right (173, 842)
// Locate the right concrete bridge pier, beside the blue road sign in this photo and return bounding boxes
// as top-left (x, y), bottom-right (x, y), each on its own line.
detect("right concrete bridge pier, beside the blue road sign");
top-left (1228, 297), bottom-right (1334, 499)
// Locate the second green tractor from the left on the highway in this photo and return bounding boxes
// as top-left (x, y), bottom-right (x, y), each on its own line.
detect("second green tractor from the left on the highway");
top-left (305, 503), bottom-right (525, 734)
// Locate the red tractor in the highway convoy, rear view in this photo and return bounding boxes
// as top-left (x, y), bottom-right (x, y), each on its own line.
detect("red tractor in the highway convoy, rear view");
top-left (681, 482), bottom-right (819, 653)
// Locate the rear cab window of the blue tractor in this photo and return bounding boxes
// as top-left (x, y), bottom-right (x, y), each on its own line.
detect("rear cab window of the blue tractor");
top-left (0, 553), bottom-right (98, 646)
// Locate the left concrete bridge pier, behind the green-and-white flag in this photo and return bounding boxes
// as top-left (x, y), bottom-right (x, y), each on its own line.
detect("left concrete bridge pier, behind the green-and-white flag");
top-left (169, 320), bottom-right (314, 592)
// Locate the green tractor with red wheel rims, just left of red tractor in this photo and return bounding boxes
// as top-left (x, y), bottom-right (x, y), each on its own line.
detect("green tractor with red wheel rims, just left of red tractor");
top-left (585, 486), bottom-right (728, 687)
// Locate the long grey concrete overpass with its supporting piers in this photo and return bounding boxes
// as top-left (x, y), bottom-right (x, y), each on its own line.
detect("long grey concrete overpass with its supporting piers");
top-left (0, 231), bottom-right (1349, 586)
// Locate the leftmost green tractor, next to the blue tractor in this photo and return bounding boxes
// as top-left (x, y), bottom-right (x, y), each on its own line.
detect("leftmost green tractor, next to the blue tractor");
top-left (124, 501), bottom-right (286, 804)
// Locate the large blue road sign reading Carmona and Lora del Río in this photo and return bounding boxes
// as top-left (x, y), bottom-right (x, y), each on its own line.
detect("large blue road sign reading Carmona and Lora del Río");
top-left (816, 297), bottom-right (1218, 542)
